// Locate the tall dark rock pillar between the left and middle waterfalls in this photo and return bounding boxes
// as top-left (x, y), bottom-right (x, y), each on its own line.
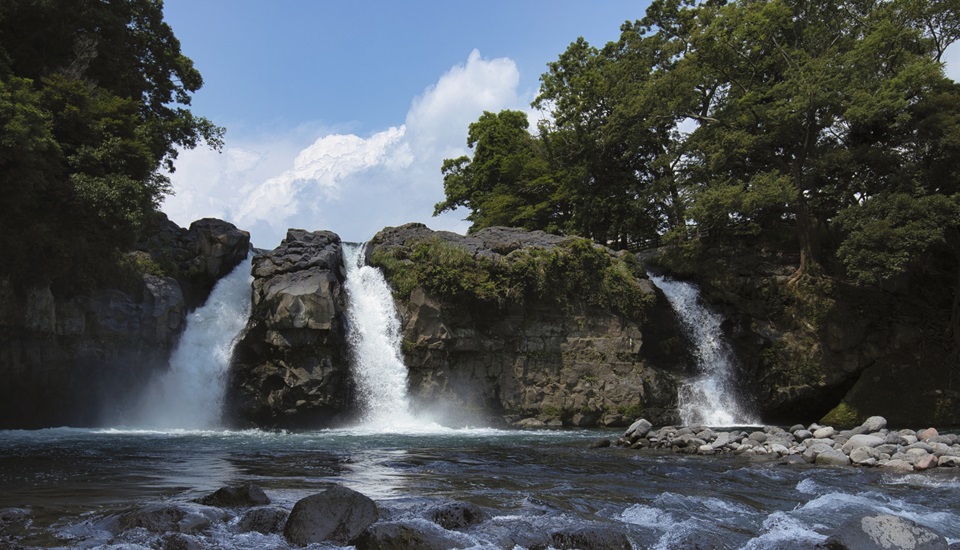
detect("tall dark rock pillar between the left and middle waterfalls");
top-left (227, 229), bottom-right (354, 428)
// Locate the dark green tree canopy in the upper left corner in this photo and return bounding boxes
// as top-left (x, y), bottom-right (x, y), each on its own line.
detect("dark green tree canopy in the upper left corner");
top-left (0, 0), bottom-right (223, 289)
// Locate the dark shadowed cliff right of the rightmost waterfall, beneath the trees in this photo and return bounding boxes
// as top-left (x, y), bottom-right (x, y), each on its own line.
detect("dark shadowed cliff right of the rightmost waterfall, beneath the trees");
top-left (650, 247), bottom-right (960, 432)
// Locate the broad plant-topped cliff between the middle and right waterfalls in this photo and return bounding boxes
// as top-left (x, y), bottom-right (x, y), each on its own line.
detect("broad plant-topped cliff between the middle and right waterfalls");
top-left (367, 224), bottom-right (686, 426)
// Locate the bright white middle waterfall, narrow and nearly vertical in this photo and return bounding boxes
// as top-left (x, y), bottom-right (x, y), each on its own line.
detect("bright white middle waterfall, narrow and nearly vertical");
top-left (343, 244), bottom-right (420, 428)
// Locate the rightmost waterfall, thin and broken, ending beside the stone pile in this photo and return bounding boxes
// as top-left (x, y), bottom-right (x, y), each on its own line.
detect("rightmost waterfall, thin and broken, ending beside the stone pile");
top-left (650, 275), bottom-right (759, 426)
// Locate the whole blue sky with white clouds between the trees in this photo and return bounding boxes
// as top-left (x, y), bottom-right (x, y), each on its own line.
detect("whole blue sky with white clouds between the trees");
top-left (163, 0), bottom-right (649, 248)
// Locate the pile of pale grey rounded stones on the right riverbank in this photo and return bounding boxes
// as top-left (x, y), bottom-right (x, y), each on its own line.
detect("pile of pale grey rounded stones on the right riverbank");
top-left (612, 416), bottom-right (960, 471)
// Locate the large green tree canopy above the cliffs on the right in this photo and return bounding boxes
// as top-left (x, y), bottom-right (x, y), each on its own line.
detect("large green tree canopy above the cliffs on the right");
top-left (438, 0), bottom-right (960, 344)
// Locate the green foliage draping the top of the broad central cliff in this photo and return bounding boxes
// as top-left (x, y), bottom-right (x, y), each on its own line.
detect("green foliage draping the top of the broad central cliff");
top-left (371, 238), bottom-right (653, 318)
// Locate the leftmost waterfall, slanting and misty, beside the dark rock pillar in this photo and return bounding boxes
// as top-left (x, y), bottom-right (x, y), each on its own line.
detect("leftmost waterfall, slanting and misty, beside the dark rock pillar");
top-left (135, 256), bottom-right (253, 429)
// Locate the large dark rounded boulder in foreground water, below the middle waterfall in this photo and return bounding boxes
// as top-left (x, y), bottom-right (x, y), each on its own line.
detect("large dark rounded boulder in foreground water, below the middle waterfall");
top-left (283, 485), bottom-right (379, 546)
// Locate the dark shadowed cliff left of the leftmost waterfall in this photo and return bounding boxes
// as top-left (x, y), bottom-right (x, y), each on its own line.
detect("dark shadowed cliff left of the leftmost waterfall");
top-left (0, 217), bottom-right (250, 428)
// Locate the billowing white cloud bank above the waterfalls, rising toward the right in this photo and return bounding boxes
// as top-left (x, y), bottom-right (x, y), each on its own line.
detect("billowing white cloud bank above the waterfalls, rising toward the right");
top-left (164, 50), bottom-right (529, 248)
